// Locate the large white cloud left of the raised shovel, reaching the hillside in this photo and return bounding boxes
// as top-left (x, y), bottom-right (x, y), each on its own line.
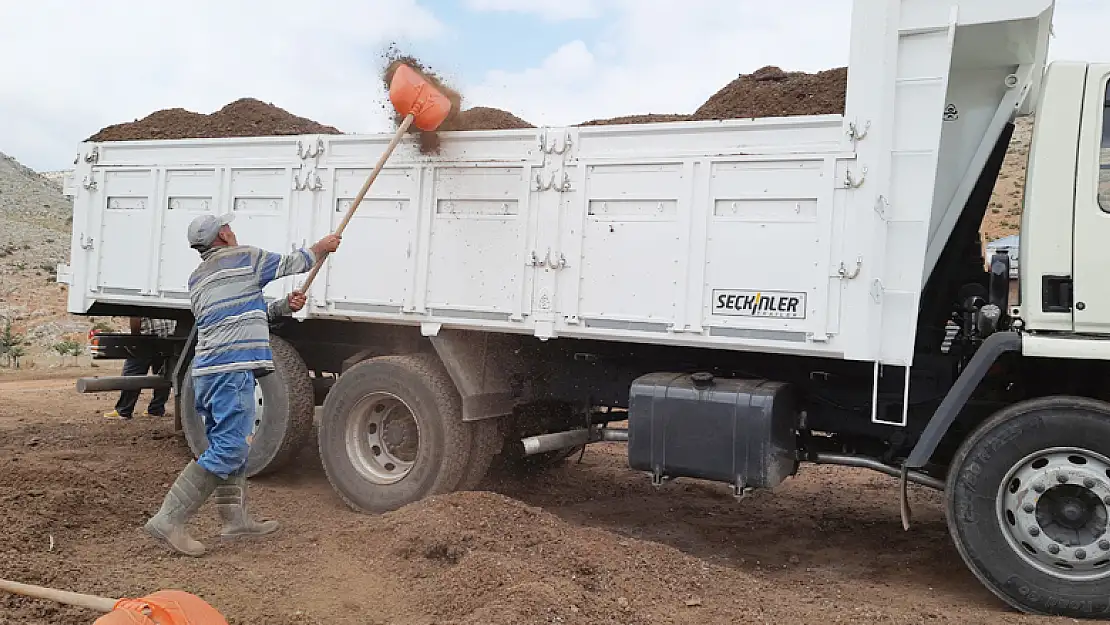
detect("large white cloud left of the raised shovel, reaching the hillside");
top-left (0, 0), bottom-right (445, 170)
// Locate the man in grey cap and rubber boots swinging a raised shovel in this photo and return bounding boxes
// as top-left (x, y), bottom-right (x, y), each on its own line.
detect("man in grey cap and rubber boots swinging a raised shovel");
top-left (144, 214), bottom-right (340, 556)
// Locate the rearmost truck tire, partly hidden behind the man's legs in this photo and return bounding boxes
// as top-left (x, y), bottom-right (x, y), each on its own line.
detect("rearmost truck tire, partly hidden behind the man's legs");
top-left (181, 336), bottom-right (315, 477)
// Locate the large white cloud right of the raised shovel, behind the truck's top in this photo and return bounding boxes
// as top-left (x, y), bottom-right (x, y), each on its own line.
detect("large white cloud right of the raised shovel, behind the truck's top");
top-left (464, 0), bottom-right (1110, 124)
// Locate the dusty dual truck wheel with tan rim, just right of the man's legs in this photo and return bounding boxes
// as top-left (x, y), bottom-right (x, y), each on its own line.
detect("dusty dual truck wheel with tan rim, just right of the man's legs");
top-left (319, 354), bottom-right (472, 513)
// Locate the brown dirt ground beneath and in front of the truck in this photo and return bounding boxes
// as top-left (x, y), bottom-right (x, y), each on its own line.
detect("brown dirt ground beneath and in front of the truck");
top-left (0, 370), bottom-right (1052, 625)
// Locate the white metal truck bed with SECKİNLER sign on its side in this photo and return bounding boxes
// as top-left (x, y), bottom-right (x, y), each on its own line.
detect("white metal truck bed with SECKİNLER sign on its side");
top-left (59, 0), bottom-right (1052, 364)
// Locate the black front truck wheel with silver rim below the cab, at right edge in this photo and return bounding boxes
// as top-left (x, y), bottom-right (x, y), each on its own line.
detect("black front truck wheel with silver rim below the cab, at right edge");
top-left (946, 396), bottom-right (1110, 618)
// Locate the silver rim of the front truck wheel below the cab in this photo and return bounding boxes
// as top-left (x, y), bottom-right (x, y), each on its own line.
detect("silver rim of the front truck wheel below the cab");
top-left (998, 447), bottom-right (1110, 581)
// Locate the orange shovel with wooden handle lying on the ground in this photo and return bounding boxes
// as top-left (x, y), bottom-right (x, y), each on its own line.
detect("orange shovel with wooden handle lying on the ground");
top-left (0, 579), bottom-right (228, 625)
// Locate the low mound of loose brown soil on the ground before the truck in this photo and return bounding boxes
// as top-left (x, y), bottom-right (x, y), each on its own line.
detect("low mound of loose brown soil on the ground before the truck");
top-left (374, 492), bottom-right (745, 625)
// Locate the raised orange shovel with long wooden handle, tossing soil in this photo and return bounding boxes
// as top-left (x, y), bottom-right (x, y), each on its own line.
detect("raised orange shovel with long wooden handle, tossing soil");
top-left (300, 63), bottom-right (451, 293)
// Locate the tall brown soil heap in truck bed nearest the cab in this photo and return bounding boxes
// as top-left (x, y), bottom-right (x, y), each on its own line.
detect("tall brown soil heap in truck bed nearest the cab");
top-left (690, 65), bottom-right (848, 120)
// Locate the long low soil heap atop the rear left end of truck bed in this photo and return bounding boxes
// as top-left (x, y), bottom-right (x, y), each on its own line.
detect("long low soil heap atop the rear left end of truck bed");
top-left (85, 98), bottom-right (342, 141)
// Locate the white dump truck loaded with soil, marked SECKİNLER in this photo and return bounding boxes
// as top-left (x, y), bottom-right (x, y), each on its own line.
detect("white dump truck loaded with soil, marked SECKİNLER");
top-left (59, 0), bottom-right (1110, 617)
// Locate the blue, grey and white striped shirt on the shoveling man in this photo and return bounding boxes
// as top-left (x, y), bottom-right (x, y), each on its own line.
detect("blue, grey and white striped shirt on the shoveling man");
top-left (189, 245), bottom-right (316, 376)
